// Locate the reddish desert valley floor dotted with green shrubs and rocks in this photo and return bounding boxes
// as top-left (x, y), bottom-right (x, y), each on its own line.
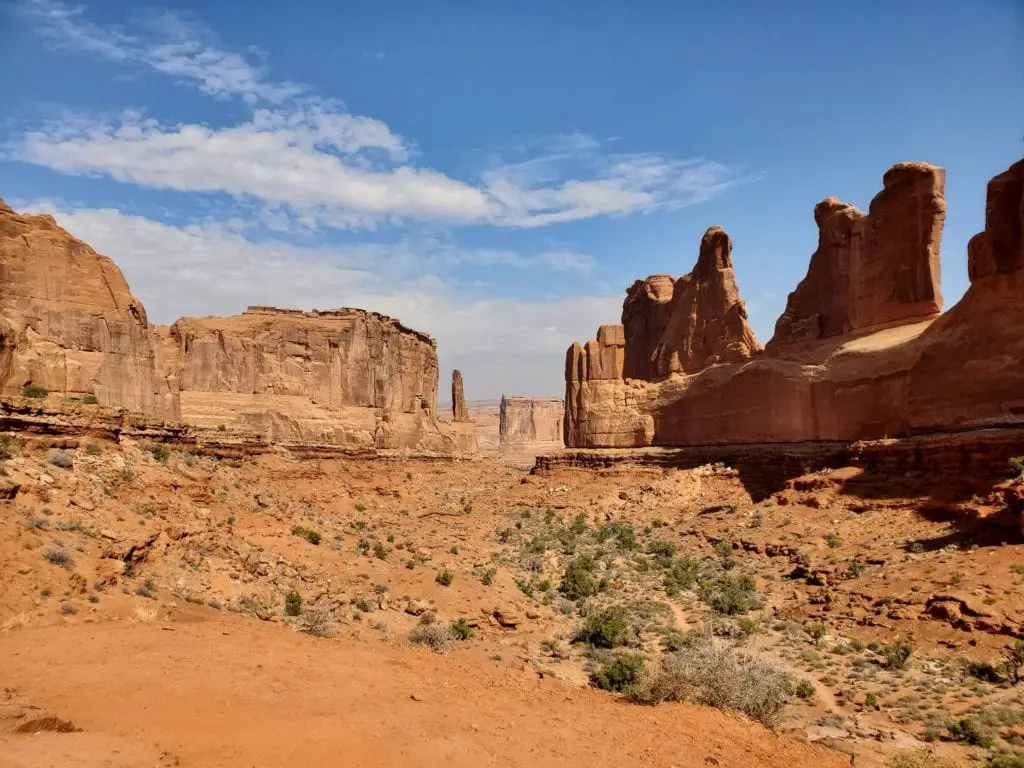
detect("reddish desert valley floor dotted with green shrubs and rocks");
top-left (0, 438), bottom-right (1024, 768)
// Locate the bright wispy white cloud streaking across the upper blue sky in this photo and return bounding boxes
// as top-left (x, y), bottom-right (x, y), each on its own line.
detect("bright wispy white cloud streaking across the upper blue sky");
top-left (6, 0), bottom-right (739, 229)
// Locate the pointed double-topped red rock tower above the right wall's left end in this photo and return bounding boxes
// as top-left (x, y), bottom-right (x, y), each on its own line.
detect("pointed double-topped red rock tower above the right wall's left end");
top-left (623, 226), bottom-right (761, 381)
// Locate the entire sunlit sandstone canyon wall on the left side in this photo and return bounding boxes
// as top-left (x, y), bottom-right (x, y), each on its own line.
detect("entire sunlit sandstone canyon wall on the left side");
top-left (0, 195), bottom-right (476, 453)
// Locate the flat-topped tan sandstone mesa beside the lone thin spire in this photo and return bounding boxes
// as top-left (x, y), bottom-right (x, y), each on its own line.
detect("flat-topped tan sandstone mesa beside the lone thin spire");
top-left (156, 307), bottom-right (471, 451)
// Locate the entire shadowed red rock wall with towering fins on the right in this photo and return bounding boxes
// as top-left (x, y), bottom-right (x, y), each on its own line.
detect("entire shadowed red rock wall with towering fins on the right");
top-left (565, 161), bottom-right (1024, 447)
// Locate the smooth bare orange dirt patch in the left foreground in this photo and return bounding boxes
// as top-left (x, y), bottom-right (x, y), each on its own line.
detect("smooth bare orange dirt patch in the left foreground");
top-left (0, 611), bottom-right (846, 768)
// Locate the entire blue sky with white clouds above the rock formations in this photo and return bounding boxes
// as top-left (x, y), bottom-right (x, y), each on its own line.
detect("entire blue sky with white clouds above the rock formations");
top-left (0, 0), bottom-right (1024, 398)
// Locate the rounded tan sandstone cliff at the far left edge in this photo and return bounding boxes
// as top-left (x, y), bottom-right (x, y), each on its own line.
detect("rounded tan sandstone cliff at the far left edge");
top-left (0, 200), bottom-right (178, 419)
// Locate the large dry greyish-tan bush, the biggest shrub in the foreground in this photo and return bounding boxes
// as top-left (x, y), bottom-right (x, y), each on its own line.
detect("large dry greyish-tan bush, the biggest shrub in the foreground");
top-left (632, 640), bottom-right (794, 728)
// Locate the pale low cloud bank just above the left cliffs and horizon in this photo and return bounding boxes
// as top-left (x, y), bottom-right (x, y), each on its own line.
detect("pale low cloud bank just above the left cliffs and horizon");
top-left (29, 202), bottom-right (622, 397)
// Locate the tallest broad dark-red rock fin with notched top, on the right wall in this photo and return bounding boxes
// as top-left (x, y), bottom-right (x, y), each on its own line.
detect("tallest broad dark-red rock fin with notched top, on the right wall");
top-left (767, 163), bottom-right (946, 354)
